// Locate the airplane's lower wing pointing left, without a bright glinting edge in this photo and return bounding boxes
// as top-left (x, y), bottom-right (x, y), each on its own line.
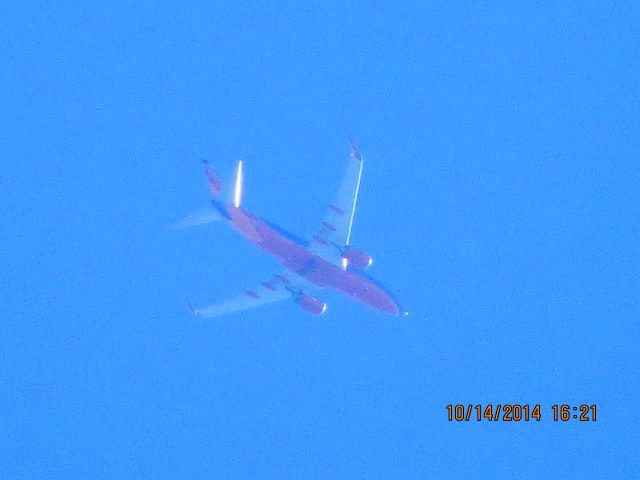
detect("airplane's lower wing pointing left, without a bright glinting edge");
top-left (191, 272), bottom-right (308, 318)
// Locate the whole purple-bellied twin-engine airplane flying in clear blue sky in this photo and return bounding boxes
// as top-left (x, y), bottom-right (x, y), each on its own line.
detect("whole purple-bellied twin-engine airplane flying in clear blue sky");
top-left (174, 141), bottom-right (408, 318)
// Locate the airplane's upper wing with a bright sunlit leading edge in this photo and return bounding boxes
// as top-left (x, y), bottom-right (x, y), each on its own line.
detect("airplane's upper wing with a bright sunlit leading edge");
top-left (309, 142), bottom-right (363, 266)
